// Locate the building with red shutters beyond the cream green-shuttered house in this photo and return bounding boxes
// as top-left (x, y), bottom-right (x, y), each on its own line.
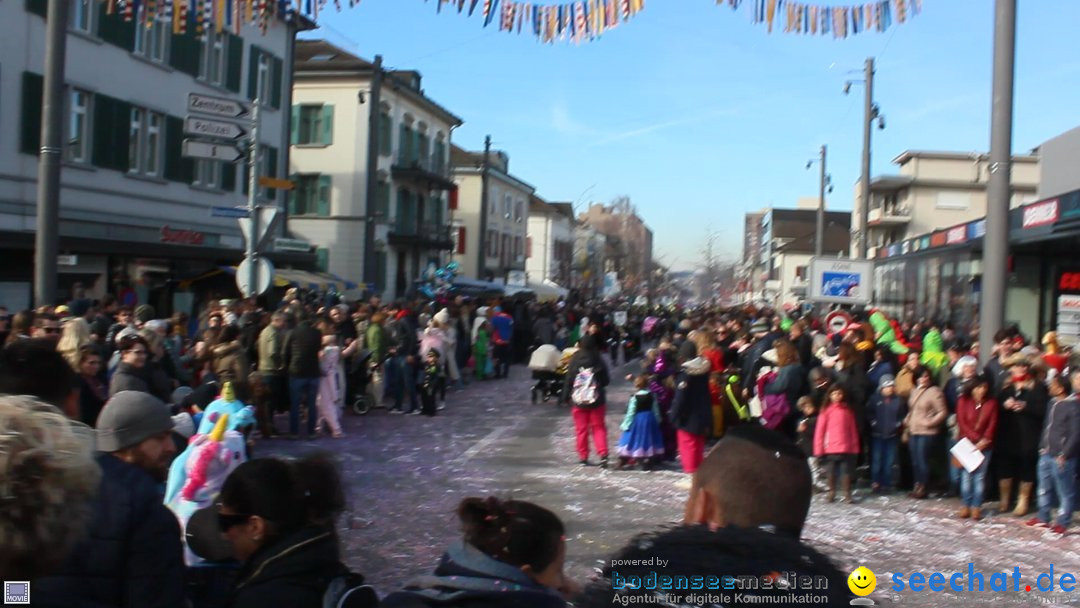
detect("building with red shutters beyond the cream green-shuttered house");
top-left (450, 146), bottom-right (536, 281)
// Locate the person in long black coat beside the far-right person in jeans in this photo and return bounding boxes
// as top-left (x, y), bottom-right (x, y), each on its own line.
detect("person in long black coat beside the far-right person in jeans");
top-left (995, 353), bottom-right (1049, 517)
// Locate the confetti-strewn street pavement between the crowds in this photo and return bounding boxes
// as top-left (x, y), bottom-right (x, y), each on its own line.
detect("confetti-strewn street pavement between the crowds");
top-left (256, 364), bottom-right (1080, 607)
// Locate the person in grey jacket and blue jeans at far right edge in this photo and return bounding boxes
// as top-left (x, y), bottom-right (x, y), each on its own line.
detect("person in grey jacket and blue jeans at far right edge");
top-left (1027, 370), bottom-right (1080, 535)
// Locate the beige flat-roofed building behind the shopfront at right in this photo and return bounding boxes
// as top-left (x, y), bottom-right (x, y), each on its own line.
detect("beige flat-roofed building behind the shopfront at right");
top-left (853, 150), bottom-right (1039, 258)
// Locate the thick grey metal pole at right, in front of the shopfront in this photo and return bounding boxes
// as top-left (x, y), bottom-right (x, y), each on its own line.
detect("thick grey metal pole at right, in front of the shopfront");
top-left (978, 0), bottom-right (1016, 362)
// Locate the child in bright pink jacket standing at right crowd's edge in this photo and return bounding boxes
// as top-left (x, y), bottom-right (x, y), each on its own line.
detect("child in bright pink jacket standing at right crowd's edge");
top-left (813, 384), bottom-right (859, 503)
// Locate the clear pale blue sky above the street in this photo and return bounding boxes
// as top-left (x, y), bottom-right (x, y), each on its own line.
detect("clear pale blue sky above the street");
top-left (305, 0), bottom-right (1080, 270)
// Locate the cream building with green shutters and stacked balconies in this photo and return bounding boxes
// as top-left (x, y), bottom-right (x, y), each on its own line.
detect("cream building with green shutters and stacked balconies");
top-left (289, 40), bottom-right (461, 298)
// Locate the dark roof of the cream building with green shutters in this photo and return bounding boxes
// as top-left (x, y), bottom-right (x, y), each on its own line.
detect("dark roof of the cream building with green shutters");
top-left (293, 40), bottom-right (464, 125)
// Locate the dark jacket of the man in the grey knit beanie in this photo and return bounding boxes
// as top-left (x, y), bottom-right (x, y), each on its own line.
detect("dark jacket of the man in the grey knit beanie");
top-left (30, 452), bottom-right (186, 608)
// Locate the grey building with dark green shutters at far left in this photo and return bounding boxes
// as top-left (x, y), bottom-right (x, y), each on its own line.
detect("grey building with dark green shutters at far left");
top-left (0, 0), bottom-right (313, 312)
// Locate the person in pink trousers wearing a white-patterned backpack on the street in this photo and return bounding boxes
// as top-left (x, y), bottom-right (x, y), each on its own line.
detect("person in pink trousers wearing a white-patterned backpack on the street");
top-left (563, 335), bottom-right (610, 469)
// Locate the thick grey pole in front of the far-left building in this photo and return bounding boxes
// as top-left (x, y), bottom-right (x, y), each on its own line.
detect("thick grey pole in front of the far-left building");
top-left (33, 0), bottom-right (69, 306)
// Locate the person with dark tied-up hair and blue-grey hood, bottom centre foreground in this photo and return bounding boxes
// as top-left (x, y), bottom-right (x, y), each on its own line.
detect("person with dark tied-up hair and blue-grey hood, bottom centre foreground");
top-left (379, 497), bottom-right (575, 608)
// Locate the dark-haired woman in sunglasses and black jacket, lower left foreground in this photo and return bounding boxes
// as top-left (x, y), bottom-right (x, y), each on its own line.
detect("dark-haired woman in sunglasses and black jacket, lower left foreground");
top-left (218, 456), bottom-right (348, 608)
